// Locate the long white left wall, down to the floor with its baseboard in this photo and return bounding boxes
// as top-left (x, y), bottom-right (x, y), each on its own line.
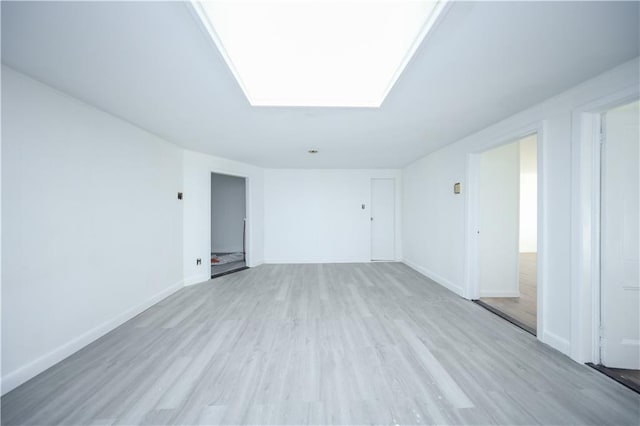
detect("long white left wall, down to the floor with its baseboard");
top-left (2, 67), bottom-right (182, 392)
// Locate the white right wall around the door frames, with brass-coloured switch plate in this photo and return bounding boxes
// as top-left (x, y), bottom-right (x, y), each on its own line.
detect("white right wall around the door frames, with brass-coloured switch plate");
top-left (403, 59), bottom-right (640, 354)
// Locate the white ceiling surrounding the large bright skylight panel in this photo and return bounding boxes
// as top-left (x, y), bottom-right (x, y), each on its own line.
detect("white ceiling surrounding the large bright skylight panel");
top-left (2, 1), bottom-right (640, 168)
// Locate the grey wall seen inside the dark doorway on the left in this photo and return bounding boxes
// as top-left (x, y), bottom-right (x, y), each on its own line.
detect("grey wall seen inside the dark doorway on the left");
top-left (212, 173), bottom-right (247, 253)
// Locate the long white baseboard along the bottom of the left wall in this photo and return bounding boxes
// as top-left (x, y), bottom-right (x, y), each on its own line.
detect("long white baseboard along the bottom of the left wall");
top-left (0, 282), bottom-right (183, 395)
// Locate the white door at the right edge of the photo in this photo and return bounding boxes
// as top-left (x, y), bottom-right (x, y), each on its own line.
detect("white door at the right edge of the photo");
top-left (600, 102), bottom-right (640, 369)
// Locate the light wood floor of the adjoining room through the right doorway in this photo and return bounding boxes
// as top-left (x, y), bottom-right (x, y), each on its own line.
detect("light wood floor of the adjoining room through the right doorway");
top-left (480, 253), bottom-right (538, 330)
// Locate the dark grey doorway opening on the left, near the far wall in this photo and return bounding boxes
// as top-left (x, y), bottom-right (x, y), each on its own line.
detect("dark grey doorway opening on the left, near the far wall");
top-left (211, 173), bottom-right (247, 278)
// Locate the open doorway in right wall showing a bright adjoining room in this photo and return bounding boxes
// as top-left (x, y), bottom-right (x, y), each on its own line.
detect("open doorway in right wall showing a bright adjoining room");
top-left (476, 133), bottom-right (538, 335)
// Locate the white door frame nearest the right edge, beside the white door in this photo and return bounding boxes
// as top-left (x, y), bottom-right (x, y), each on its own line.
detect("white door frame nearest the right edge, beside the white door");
top-left (570, 85), bottom-right (640, 364)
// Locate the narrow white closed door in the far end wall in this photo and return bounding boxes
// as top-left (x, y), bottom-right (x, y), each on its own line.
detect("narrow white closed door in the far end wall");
top-left (371, 179), bottom-right (396, 260)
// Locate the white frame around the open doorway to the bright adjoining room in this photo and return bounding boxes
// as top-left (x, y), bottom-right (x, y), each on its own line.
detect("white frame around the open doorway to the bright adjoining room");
top-left (463, 121), bottom-right (547, 341)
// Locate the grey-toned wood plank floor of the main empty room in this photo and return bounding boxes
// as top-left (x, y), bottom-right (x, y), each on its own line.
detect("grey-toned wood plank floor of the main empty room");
top-left (2, 263), bottom-right (640, 425)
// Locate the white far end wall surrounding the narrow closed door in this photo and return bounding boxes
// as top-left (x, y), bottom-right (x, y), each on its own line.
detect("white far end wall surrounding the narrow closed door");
top-left (265, 170), bottom-right (402, 263)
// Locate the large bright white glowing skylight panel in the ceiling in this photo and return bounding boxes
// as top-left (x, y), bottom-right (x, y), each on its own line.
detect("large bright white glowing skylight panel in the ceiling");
top-left (193, 0), bottom-right (444, 107)
